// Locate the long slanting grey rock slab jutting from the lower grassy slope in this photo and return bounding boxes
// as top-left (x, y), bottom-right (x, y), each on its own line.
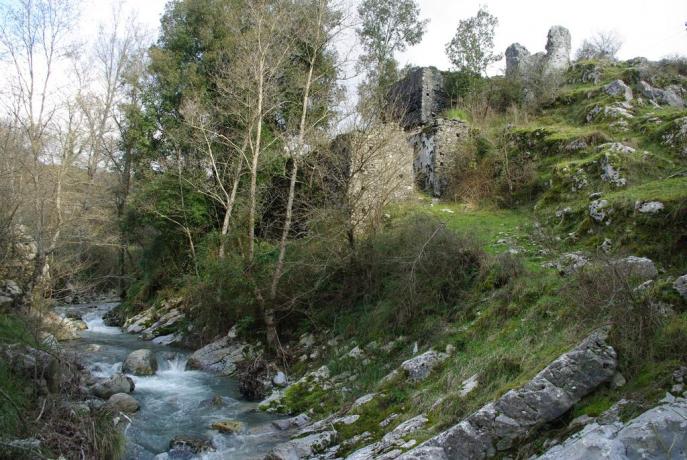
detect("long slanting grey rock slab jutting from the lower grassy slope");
top-left (400, 331), bottom-right (617, 460)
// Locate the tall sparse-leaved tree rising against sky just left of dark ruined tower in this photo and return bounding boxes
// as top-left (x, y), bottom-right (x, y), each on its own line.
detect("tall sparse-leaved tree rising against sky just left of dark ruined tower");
top-left (356, 0), bottom-right (428, 99)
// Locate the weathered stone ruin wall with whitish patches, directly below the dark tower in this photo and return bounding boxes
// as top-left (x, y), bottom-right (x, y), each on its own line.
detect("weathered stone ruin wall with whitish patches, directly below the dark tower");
top-left (409, 118), bottom-right (470, 196)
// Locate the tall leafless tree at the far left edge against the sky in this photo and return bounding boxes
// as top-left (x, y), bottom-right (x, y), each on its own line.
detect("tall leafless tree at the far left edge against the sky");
top-left (0, 0), bottom-right (78, 304)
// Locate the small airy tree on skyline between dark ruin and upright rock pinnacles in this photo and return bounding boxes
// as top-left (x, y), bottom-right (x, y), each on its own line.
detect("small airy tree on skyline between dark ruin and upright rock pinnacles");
top-left (446, 6), bottom-right (501, 74)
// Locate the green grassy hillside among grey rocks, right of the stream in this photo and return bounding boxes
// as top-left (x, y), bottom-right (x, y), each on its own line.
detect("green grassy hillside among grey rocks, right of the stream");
top-left (268, 60), bottom-right (687, 451)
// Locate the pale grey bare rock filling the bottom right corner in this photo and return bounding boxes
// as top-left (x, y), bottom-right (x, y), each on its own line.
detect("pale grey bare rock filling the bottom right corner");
top-left (538, 396), bottom-right (687, 460)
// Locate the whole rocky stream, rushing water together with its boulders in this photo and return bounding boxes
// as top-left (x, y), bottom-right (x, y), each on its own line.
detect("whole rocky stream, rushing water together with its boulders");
top-left (58, 303), bottom-right (285, 460)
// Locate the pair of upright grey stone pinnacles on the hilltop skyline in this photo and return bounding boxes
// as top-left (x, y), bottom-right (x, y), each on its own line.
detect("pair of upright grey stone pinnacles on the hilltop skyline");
top-left (506, 26), bottom-right (572, 79)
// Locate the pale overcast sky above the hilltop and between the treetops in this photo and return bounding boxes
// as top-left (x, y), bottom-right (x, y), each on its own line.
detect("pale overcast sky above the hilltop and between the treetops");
top-left (84, 0), bottom-right (687, 74)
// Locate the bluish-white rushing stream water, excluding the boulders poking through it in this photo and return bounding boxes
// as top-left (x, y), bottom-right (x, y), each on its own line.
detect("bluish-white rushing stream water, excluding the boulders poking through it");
top-left (57, 303), bottom-right (283, 460)
